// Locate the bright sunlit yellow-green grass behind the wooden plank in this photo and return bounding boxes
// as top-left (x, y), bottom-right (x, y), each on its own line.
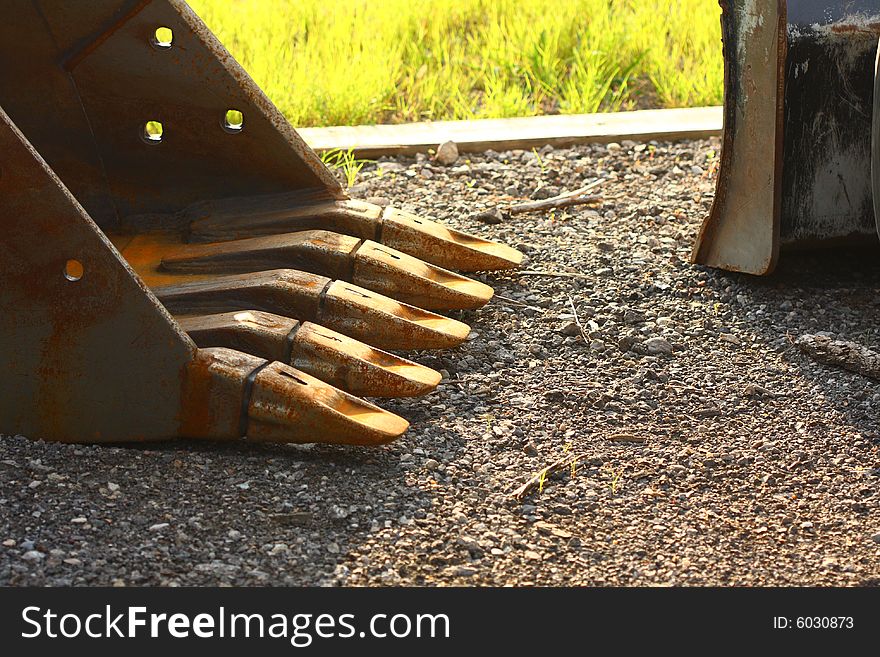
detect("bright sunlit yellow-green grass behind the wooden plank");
top-left (190, 0), bottom-right (723, 126)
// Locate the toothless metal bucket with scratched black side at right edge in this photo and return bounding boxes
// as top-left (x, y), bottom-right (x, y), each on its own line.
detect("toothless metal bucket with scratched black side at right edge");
top-left (693, 0), bottom-right (880, 275)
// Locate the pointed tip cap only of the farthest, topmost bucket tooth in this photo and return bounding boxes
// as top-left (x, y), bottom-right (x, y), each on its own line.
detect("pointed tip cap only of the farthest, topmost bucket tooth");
top-left (379, 208), bottom-right (523, 272)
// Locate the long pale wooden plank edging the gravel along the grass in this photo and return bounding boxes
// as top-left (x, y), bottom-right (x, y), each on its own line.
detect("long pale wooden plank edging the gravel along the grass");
top-left (299, 107), bottom-right (722, 158)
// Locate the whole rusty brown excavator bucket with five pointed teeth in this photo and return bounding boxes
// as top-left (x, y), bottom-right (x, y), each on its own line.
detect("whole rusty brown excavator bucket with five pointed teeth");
top-left (0, 0), bottom-right (521, 445)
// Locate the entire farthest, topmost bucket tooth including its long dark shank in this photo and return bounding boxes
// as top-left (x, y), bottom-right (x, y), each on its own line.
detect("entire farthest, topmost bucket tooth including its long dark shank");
top-left (185, 199), bottom-right (523, 272)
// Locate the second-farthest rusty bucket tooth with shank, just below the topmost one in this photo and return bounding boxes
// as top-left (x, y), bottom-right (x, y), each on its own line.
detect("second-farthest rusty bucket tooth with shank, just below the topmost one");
top-left (160, 230), bottom-right (493, 310)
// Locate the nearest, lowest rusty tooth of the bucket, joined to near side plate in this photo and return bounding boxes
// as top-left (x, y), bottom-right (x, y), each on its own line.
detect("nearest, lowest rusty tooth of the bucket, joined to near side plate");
top-left (180, 349), bottom-right (409, 445)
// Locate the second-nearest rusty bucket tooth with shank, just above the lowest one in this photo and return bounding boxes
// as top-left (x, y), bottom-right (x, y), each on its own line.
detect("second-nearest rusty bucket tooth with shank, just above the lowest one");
top-left (178, 311), bottom-right (441, 397)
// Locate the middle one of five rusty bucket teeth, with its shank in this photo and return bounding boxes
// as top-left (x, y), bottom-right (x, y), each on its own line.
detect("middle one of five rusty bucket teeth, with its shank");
top-left (153, 269), bottom-right (470, 349)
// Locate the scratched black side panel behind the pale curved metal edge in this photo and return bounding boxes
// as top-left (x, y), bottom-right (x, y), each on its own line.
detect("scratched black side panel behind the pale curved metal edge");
top-left (781, 0), bottom-right (880, 243)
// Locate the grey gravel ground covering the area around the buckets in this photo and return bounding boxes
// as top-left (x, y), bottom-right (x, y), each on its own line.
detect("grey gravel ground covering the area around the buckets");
top-left (0, 141), bottom-right (880, 585)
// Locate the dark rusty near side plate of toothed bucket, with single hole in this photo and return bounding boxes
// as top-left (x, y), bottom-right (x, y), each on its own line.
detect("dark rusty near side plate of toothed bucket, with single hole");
top-left (0, 110), bottom-right (196, 441)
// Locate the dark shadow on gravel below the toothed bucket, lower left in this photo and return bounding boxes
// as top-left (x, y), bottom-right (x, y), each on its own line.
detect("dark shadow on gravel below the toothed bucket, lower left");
top-left (0, 430), bottom-right (431, 585)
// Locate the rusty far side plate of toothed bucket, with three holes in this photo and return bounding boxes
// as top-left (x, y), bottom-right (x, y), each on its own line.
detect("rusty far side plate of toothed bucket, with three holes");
top-left (0, 0), bottom-right (344, 230)
